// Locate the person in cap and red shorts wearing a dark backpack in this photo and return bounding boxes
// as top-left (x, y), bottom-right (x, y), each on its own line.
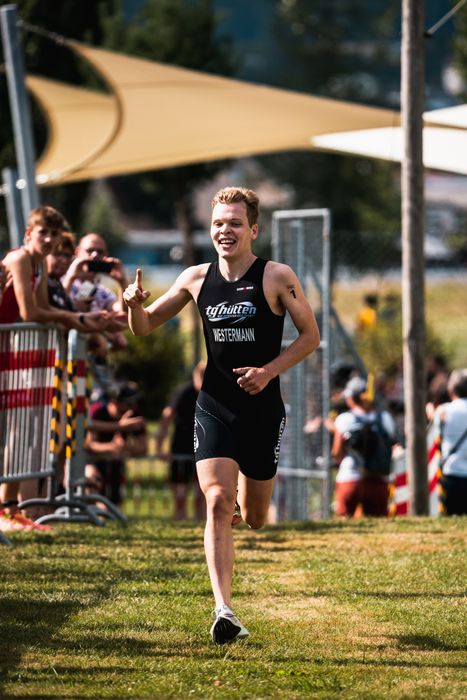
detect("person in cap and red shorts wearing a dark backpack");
top-left (332, 377), bottom-right (396, 517)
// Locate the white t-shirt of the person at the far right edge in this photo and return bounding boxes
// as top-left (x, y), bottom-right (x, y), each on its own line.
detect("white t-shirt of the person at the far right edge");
top-left (434, 399), bottom-right (467, 477)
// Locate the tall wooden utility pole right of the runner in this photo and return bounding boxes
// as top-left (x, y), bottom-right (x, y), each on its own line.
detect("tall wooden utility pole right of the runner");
top-left (401, 0), bottom-right (428, 515)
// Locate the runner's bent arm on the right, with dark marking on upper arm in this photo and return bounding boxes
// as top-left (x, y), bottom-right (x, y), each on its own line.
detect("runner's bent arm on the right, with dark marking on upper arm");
top-left (234, 263), bottom-right (320, 395)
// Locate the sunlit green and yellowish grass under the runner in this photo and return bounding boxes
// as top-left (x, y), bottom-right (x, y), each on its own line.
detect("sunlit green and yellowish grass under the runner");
top-left (0, 518), bottom-right (467, 700)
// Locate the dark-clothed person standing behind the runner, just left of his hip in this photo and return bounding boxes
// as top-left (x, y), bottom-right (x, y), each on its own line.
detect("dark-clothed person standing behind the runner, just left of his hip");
top-left (156, 361), bottom-right (206, 520)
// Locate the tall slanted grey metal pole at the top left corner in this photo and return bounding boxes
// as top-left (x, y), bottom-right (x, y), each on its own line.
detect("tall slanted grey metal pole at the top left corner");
top-left (0, 5), bottom-right (39, 221)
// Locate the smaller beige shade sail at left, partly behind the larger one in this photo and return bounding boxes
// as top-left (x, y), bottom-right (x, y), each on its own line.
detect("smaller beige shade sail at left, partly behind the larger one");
top-left (27, 76), bottom-right (120, 184)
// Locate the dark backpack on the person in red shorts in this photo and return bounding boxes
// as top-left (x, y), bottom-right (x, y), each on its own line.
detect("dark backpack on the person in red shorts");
top-left (345, 413), bottom-right (394, 476)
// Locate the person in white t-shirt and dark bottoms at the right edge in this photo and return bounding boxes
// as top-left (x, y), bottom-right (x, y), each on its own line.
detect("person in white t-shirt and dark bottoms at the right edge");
top-left (434, 369), bottom-right (467, 515)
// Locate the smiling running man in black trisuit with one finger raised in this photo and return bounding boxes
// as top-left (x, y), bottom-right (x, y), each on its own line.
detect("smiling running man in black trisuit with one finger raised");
top-left (123, 187), bottom-right (319, 644)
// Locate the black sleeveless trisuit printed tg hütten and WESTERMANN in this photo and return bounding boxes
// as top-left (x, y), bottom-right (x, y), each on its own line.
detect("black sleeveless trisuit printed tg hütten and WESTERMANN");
top-left (195, 258), bottom-right (285, 480)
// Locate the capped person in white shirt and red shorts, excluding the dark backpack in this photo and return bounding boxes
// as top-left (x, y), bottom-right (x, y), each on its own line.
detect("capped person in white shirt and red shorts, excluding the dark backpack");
top-left (331, 377), bottom-right (396, 517)
